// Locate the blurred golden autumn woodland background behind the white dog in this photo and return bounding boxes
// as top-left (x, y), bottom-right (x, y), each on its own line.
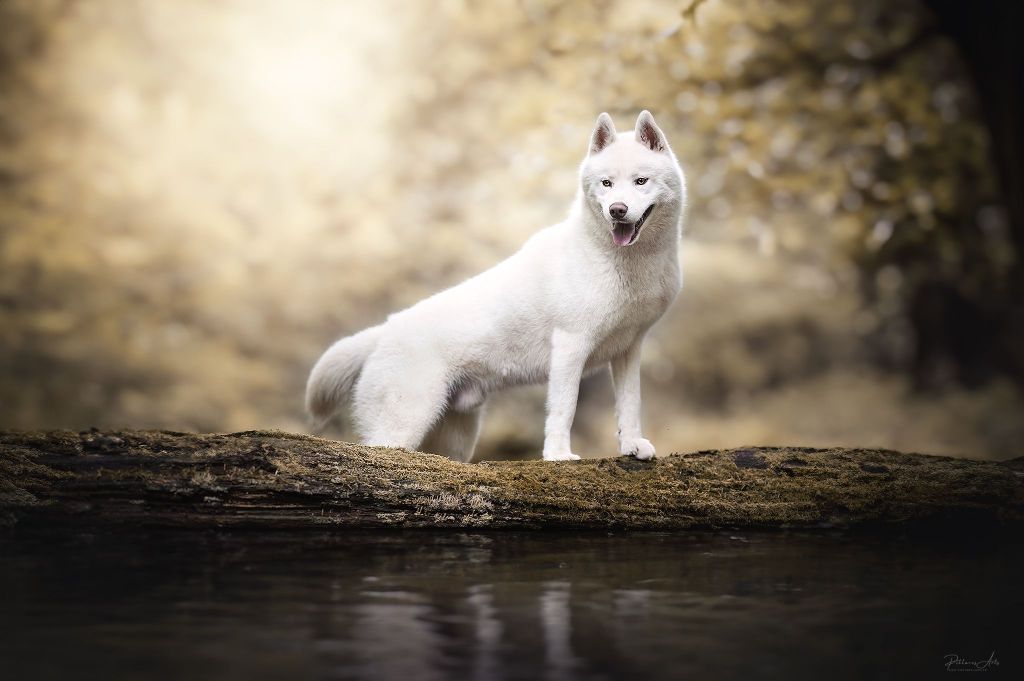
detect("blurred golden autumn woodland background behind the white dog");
top-left (0, 0), bottom-right (1024, 458)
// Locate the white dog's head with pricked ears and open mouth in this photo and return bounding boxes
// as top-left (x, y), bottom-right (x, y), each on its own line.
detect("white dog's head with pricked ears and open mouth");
top-left (580, 111), bottom-right (685, 247)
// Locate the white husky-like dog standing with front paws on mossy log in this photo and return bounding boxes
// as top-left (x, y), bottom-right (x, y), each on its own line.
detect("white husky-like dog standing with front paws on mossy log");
top-left (306, 111), bottom-right (686, 461)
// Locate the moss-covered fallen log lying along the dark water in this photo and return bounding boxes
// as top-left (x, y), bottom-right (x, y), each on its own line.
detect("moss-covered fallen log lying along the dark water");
top-left (0, 431), bottom-right (1024, 529)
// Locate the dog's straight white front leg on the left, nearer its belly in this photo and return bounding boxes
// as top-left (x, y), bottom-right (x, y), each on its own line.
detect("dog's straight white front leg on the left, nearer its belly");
top-left (544, 330), bottom-right (591, 461)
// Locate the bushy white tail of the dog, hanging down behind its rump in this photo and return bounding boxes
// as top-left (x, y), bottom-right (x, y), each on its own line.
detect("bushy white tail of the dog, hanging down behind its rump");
top-left (306, 327), bottom-right (381, 430)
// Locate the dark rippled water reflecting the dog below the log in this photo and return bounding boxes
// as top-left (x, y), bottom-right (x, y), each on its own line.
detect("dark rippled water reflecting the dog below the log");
top-left (0, 530), bottom-right (1024, 680)
